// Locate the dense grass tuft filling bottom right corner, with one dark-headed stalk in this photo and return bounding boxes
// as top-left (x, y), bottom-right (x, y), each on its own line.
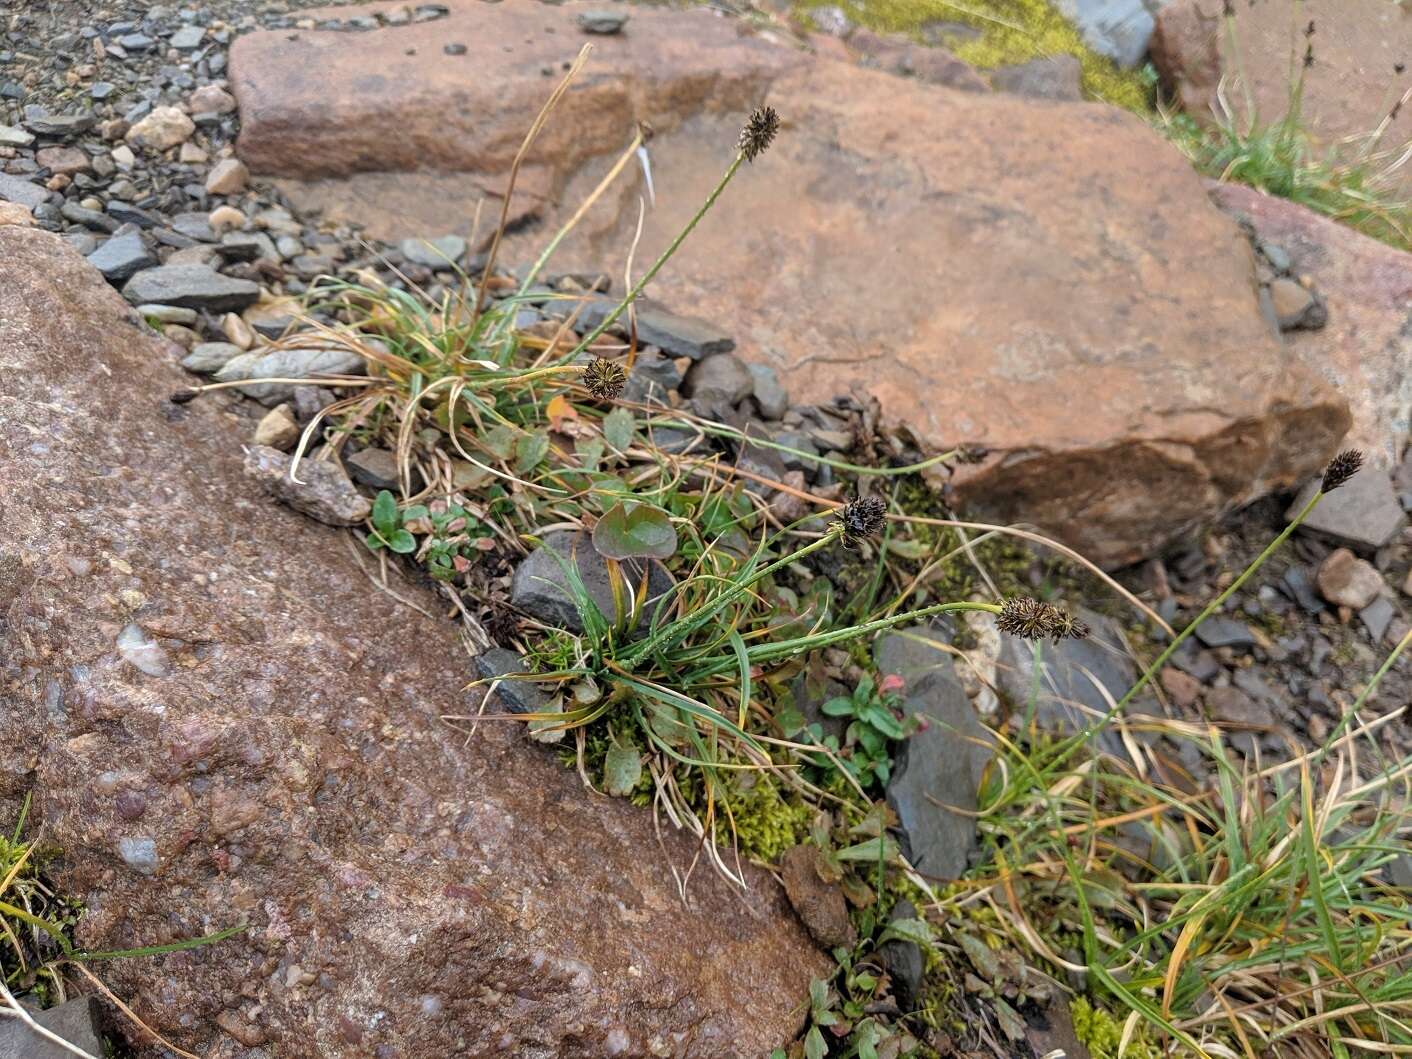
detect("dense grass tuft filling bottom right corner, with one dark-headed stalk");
top-left (932, 457), bottom-right (1412, 1056)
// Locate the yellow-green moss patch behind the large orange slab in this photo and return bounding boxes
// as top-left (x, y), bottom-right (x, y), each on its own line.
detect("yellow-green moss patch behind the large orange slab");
top-left (796, 0), bottom-right (1152, 114)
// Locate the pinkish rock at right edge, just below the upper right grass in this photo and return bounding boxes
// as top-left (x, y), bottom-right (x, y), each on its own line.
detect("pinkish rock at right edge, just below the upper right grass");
top-left (1211, 184), bottom-right (1412, 467)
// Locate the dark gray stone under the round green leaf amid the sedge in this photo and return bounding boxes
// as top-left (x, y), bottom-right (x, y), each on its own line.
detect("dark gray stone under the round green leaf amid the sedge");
top-left (510, 530), bottom-right (672, 633)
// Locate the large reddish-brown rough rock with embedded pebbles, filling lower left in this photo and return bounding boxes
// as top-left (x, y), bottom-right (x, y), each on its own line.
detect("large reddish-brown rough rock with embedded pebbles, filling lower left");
top-left (0, 227), bottom-right (827, 1059)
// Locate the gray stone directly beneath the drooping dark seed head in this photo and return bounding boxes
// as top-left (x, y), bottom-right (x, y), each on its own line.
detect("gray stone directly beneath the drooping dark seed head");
top-left (995, 610), bottom-right (1157, 758)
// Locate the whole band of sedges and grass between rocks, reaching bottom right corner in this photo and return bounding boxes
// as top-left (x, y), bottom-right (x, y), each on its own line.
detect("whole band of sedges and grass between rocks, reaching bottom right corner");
top-left (184, 37), bottom-right (1412, 1059)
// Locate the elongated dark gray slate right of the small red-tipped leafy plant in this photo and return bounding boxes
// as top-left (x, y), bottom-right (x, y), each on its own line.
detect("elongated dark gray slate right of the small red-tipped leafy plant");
top-left (878, 638), bottom-right (991, 878)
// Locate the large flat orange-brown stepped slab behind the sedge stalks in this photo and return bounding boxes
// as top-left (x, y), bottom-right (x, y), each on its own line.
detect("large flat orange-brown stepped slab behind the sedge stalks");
top-left (232, 0), bottom-right (1348, 565)
